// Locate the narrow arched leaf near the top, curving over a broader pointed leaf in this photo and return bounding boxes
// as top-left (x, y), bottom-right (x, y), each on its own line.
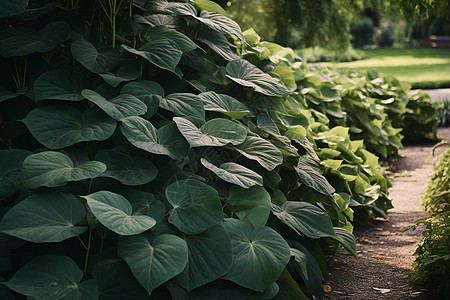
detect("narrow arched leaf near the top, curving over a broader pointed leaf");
top-left (144, 26), bottom-right (198, 52)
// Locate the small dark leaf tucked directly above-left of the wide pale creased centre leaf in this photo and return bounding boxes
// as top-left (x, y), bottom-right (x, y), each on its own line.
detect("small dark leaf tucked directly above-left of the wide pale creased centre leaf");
top-left (159, 93), bottom-right (205, 126)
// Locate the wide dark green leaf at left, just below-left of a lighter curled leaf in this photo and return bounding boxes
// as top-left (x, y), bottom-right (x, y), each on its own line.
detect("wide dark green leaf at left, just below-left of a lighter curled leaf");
top-left (23, 104), bottom-right (116, 149)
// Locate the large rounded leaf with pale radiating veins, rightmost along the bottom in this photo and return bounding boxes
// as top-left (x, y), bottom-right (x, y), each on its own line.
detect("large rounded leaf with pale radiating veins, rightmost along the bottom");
top-left (223, 219), bottom-right (290, 291)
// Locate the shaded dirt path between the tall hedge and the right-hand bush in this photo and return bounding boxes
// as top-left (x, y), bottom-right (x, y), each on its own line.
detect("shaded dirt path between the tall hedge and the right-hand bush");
top-left (323, 127), bottom-right (450, 300)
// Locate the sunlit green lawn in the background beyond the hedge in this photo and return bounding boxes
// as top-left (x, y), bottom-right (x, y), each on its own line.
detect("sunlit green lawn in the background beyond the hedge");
top-left (320, 48), bottom-right (450, 88)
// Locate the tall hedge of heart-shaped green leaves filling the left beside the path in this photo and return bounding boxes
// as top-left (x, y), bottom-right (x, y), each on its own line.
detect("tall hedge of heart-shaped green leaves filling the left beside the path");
top-left (0, 0), bottom-right (440, 299)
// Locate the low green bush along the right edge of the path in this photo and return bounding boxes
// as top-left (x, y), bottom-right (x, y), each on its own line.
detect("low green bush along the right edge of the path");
top-left (408, 149), bottom-right (450, 297)
